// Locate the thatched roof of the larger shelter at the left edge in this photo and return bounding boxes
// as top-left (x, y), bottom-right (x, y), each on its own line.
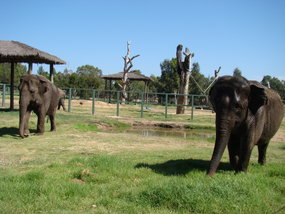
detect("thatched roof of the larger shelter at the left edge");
top-left (0, 40), bottom-right (66, 64)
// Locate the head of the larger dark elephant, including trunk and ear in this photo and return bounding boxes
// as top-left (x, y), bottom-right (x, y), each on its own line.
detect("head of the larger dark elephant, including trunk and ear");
top-left (207, 76), bottom-right (267, 176)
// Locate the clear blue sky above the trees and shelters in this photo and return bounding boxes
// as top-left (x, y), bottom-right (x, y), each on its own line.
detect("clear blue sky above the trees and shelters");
top-left (0, 0), bottom-right (285, 81)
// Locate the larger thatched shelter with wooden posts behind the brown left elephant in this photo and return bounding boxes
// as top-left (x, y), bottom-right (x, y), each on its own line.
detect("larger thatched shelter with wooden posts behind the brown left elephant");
top-left (0, 40), bottom-right (66, 109)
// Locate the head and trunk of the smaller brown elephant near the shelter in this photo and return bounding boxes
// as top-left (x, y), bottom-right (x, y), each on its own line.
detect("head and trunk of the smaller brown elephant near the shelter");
top-left (19, 75), bottom-right (49, 137)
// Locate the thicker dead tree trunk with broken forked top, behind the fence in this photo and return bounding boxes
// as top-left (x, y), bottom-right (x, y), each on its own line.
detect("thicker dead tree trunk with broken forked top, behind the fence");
top-left (176, 45), bottom-right (194, 114)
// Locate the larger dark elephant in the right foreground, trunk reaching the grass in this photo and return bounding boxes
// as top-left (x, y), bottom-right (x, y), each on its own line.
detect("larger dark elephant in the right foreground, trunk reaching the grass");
top-left (207, 76), bottom-right (284, 176)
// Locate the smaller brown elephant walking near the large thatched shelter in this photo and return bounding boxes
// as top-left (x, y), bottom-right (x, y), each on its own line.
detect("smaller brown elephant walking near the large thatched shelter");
top-left (19, 74), bottom-right (65, 138)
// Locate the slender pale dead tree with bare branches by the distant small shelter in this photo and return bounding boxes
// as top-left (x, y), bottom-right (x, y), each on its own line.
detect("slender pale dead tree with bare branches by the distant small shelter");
top-left (119, 42), bottom-right (140, 104)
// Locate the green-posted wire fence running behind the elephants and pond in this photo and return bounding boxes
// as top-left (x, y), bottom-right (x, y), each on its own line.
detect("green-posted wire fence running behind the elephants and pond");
top-left (0, 84), bottom-right (212, 120)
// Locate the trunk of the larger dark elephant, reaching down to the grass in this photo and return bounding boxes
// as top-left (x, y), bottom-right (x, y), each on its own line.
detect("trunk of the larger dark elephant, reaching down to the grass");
top-left (207, 120), bottom-right (231, 176)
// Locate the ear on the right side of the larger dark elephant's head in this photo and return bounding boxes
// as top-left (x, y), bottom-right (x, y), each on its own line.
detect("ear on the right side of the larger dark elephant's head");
top-left (249, 82), bottom-right (268, 114)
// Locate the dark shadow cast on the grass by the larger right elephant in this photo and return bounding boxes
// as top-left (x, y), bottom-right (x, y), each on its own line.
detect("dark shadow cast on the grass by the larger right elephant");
top-left (135, 159), bottom-right (232, 176)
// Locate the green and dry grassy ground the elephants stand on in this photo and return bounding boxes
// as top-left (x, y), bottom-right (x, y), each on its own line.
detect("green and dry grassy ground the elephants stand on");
top-left (0, 103), bottom-right (285, 214)
